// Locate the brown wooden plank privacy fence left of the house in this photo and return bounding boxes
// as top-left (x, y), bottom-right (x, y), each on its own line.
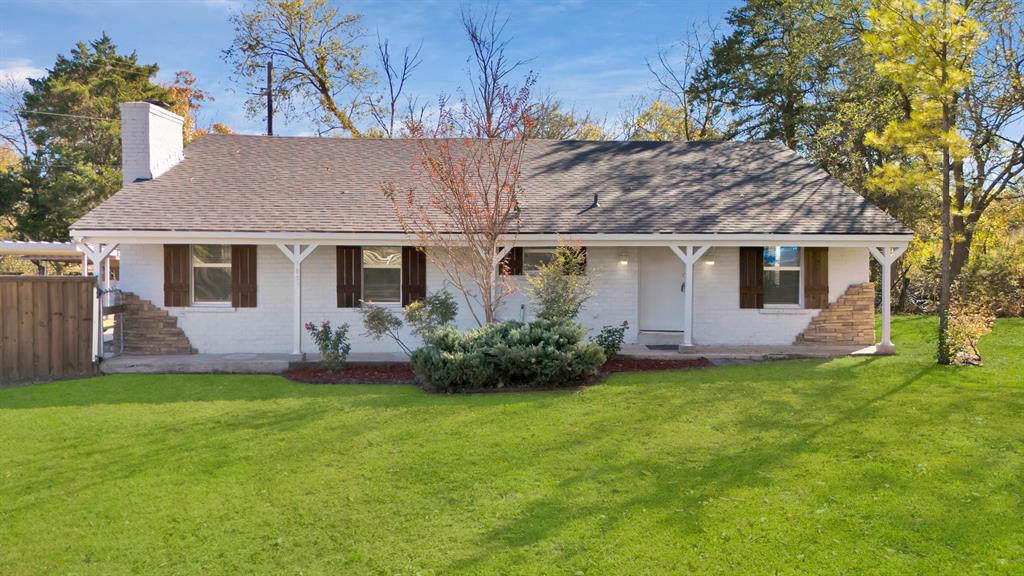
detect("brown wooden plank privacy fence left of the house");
top-left (0, 276), bottom-right (96, 384)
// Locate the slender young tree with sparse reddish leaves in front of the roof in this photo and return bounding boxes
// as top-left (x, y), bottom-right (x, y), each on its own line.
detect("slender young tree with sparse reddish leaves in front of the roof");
top-left (383, 8), bottom-right (534, 325)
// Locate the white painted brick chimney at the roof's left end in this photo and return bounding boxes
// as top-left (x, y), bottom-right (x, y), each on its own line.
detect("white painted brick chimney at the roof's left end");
top-left (121, 102), bottom-right (184, 186)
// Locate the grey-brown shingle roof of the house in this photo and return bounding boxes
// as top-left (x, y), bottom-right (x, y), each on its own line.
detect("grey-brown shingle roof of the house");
top-left (73, 134), bottom-right (910, 235)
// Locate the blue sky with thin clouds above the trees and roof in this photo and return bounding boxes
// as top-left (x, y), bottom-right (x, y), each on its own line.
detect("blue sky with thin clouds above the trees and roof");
top-left (0, 0), bottom-right (736, 134)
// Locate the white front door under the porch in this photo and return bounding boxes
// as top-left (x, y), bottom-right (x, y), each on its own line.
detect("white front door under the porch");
top-left (638, 246), bottom-right (684, 332)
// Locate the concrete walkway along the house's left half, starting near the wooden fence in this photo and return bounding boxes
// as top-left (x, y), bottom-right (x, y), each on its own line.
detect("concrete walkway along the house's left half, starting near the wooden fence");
top-left (99, 354), bottom-right (409, 374)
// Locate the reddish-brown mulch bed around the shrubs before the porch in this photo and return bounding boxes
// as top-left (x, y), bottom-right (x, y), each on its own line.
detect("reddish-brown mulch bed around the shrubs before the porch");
top-left (281, 356), bottom-right (712, 381)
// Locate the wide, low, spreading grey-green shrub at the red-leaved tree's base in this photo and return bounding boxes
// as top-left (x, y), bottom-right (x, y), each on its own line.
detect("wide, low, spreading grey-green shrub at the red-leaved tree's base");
top-left (412, 320), bottom-right (605, 392)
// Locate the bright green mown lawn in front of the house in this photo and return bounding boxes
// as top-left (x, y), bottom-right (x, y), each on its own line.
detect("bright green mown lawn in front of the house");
top-left (0, 318), bottom-right (1024, 575)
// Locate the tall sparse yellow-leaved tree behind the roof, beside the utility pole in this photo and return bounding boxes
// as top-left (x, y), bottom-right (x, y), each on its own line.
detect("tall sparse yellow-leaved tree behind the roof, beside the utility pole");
top-left (223, 0), bottom-right (374, 136)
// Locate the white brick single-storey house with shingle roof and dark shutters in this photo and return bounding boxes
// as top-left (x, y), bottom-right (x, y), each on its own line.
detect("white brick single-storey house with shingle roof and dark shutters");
top-left (72, 102), bottom-right (911, 353)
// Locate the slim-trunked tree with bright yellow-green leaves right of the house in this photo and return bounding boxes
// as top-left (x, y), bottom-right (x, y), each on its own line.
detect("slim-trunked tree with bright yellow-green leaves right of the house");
top-left (864, 0), bottom-right (984, 364)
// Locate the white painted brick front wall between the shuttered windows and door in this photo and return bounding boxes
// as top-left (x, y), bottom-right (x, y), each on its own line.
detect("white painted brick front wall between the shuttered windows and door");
top-left (121, 245), bottom-right (868, 354)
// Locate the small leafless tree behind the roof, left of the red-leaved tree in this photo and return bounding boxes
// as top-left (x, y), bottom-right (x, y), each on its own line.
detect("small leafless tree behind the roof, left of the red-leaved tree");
top-left (367, 36), bottom-right (425, 138)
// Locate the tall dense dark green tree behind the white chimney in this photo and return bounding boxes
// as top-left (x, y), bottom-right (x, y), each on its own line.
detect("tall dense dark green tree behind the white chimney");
top-left (0, 35), bottom-right (170, 240)
